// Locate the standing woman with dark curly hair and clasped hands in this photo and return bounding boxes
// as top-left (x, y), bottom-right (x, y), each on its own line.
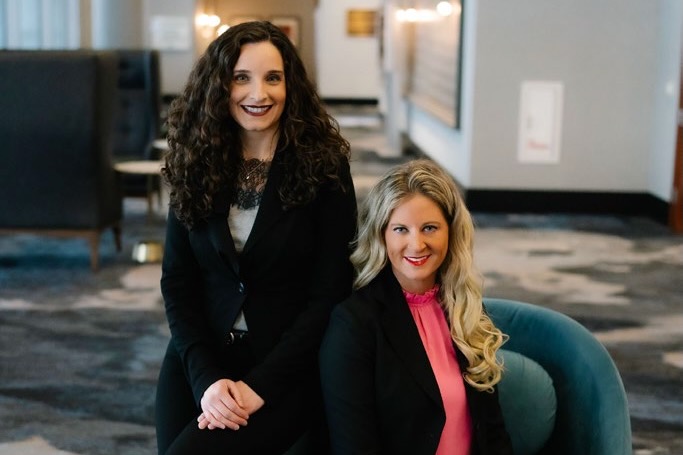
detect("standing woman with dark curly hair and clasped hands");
top-left (156, 22), bottom-right (356, 455)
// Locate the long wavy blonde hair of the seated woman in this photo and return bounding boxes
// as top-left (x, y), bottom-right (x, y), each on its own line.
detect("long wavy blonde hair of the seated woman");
top-left (351, 159), bottom-right (506, 391)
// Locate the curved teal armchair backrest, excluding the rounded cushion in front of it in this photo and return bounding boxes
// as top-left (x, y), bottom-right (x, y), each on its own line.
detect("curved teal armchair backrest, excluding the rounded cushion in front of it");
top-left (484, 298), bottom-right (633, 455)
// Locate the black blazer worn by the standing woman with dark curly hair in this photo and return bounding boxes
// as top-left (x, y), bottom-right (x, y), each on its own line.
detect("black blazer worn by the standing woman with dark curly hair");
top-left (161, 153), bottom-right (356, 404)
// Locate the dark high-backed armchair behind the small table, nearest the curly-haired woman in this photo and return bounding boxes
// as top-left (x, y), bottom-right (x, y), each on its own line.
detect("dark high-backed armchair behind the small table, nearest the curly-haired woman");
top-left (113, 49), bottom-right (161, 211)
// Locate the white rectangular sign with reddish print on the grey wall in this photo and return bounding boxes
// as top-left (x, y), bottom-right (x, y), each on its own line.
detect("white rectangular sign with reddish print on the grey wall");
top-left (517, 81), bottom-right (564, 163)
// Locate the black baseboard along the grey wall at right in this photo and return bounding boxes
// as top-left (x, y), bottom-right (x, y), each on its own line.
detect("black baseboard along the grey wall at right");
top-left (464, 189), bottom-right (669, 224)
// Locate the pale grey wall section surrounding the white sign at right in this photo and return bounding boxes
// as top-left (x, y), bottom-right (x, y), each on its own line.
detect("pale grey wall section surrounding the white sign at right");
top-left (471, 0), bottom-right (659, 192)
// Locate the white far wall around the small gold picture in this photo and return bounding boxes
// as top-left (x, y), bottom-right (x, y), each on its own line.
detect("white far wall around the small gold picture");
top-left (315, 0), bottom-right (382, 99)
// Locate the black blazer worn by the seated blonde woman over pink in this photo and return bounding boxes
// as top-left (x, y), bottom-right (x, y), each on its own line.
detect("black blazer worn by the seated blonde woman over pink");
top-left (320, 266), bottom-right (512, 455)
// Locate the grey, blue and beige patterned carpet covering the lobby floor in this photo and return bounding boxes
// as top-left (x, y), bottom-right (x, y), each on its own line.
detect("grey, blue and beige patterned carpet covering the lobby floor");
top-left (0, 116), bottom-right (683, 455)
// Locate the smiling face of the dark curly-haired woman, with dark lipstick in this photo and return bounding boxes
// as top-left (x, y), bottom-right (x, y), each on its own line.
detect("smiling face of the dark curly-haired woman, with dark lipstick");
top-left (230, 41), bottom-right (287, 140)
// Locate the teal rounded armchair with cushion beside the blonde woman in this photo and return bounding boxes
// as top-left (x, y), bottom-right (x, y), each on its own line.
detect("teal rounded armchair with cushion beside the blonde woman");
top-left (484, 298), bottom-right (633, 455)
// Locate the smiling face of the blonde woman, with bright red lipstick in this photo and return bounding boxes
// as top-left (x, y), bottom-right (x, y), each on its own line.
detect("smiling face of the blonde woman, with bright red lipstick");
top-left (384, 194), bottom-right (449, 294)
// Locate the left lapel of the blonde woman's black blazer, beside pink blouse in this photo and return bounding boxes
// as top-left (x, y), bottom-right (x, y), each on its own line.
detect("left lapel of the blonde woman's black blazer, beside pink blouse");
top-left (379, 267), bottom-right (443, 406)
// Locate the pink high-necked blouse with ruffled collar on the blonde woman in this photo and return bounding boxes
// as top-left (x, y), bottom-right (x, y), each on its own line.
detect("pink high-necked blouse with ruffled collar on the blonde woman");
top-left (403, 285), bottom-right (472, 455)
